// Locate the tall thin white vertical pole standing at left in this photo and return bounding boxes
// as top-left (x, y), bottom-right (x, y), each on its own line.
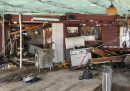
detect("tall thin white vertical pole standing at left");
top-left (19, 14), bottom-right (22, 68)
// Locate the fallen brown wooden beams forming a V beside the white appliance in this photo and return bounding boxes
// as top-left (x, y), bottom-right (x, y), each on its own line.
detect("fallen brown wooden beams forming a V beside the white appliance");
top-left (90, 48), bottom-right (126, 64)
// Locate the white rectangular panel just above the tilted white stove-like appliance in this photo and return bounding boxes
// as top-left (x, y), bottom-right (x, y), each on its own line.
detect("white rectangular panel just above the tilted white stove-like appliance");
top-left (65, 37), bottom-right (85, 49)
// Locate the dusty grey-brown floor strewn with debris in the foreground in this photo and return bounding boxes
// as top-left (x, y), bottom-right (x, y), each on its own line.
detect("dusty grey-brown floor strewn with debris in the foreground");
top-left (0, 69), bottom-right (130, 91)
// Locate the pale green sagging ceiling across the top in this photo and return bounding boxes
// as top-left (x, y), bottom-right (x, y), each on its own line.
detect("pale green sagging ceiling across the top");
top-left (0, 0), bottom-right (130, 15)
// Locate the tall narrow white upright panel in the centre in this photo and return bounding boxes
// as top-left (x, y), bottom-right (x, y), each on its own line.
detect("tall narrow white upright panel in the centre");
top-left (52, 23), bottom-right (64, 63)
